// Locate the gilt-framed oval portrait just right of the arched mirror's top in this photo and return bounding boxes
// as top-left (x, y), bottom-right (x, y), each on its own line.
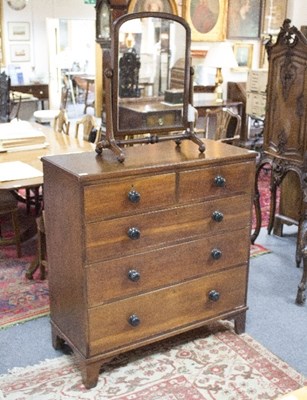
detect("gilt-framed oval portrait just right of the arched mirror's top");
top-left (182, 0), bottom-right (227, 42)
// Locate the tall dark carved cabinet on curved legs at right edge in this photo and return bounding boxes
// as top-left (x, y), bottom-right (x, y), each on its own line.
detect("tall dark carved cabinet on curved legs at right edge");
top-left (252, 19), bottom-right (307, 304)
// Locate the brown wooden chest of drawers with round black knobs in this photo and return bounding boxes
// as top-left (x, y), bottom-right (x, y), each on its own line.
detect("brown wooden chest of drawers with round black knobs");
top-left (43, 140), bottom-right (255, 388)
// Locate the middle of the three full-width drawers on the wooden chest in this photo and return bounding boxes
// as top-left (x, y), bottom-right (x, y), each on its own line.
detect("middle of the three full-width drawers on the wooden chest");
top-left (86, 228), bottom-right (250, 307)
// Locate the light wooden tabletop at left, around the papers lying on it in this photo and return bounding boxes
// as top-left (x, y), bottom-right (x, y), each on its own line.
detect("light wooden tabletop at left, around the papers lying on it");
top-left (0, 123), bottom-right (95, 190)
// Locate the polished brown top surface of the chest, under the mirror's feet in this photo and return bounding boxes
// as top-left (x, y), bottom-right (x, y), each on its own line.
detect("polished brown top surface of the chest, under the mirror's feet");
top-left (42, 140), bottom-right (256, 181)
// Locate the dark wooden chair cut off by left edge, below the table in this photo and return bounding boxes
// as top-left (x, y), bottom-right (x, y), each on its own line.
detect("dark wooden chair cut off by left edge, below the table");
top-left (0, 190), bottom-right (21, 257)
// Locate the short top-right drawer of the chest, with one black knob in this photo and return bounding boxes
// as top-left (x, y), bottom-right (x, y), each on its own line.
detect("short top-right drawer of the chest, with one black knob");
top-left (179, 162), bottom-right (255, 202)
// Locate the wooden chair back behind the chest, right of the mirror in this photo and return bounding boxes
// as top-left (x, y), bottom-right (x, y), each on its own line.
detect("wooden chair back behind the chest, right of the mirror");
top-left (204, 107), bottom-right (241, 144)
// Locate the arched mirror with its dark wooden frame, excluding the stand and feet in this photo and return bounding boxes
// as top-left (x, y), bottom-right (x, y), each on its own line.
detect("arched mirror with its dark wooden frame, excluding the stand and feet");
top-left (113, 13), bottom-right (190, 136)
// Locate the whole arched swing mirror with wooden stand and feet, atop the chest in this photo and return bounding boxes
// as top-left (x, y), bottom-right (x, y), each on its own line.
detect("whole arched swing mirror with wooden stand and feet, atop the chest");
top-left (96, 12), bottom-right (205, 161)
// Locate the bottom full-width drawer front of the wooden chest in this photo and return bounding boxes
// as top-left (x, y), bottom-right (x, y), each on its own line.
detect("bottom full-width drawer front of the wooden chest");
top-left (89, 266), bottom-right (247, 356)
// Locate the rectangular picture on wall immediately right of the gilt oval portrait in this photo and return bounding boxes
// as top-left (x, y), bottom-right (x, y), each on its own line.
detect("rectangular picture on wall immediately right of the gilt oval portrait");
top-left (227, 0), bottom-right (262, 39)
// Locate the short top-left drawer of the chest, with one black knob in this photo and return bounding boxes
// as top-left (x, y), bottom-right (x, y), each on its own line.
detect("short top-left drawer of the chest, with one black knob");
top-left (84, 173), bottom-right (176, 221)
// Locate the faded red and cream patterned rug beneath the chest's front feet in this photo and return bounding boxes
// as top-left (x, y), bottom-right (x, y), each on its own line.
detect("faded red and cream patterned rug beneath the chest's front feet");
top-left (0, 322), bottom-right (307, 400)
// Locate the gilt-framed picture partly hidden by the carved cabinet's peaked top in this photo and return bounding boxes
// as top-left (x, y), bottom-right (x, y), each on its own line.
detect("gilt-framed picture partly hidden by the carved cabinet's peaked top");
top-left (262, 0), bottom-right (288, 35)
